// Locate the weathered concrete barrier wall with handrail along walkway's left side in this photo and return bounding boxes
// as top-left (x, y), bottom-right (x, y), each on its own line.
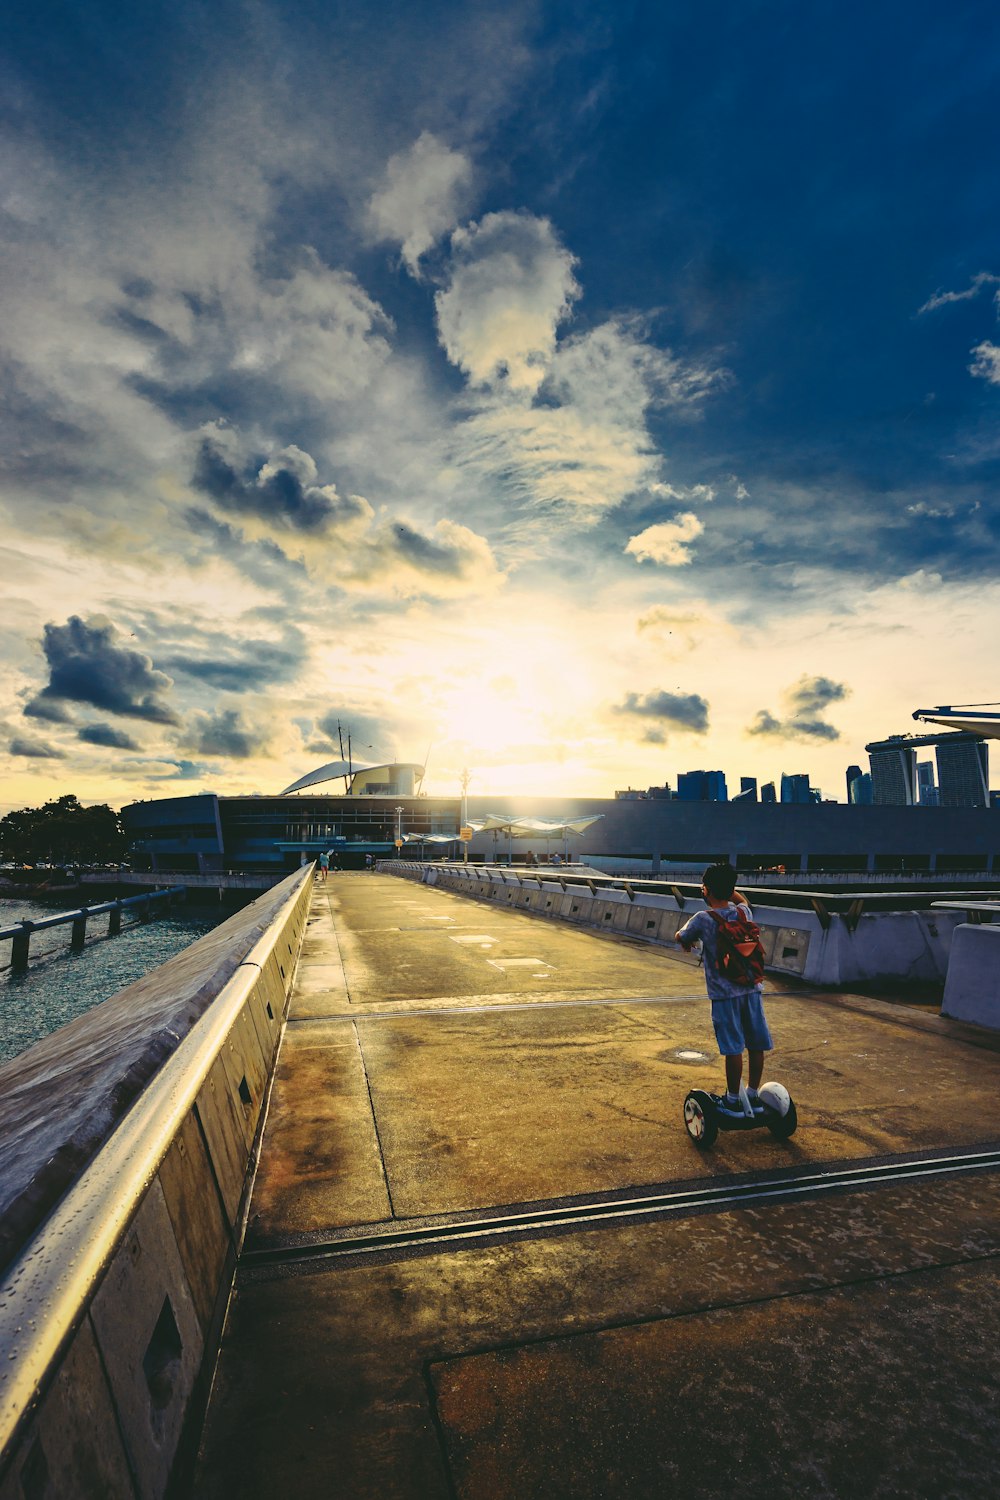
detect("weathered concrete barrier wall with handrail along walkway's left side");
top-left (0, 869), bottom-right (312, 1500)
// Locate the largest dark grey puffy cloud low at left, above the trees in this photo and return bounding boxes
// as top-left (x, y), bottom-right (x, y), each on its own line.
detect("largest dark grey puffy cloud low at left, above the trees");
top-left (39, 615), bottom-right (178, 725)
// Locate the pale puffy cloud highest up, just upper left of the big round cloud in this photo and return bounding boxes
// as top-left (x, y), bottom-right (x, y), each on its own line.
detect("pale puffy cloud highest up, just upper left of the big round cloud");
top-left (367, 131), bottom-right (472, 275)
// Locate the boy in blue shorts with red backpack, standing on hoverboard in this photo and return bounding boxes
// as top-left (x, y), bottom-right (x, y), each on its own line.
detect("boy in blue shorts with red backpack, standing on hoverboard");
top-left (678, 864), bottom-right (774, 1115)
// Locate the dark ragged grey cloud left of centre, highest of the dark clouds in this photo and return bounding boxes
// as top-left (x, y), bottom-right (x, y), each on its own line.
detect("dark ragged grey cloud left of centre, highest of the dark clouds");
top-left (192, 428), bottom-right (375, 533)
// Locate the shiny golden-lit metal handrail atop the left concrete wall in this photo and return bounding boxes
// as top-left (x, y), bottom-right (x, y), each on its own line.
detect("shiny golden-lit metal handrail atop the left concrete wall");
top-left (0, 866), bottom-right (312, 1455)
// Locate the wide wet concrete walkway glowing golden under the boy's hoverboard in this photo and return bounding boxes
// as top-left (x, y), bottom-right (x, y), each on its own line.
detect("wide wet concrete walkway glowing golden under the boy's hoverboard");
top-left (193, 873), bottom-right (1000, 1500)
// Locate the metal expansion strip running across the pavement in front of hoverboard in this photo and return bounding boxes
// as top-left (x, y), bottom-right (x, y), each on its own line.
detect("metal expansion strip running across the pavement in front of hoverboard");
top-left (238, 1149), bottom-right (1000, 1274)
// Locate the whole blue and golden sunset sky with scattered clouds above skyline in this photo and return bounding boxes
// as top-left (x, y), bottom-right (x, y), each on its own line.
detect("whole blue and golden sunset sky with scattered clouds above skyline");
top-left (0, 0), bottom-right (1000, 812)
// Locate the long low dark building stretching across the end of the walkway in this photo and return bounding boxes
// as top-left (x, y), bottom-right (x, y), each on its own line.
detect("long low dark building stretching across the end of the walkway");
top-left (121, 794), bottom-right (1000, 875)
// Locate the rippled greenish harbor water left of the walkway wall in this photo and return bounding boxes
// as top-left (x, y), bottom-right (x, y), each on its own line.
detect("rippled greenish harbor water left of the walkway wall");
top-left (0, 899), bottom-right (232, 1064)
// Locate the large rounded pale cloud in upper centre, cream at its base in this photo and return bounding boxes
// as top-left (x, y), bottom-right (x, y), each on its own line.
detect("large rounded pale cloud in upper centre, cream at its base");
top-left (435, 213), bottom-right (580, 393)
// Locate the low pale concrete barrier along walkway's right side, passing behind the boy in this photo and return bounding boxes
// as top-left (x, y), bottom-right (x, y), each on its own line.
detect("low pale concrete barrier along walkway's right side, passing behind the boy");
top-left (379, 860), bottom-right (971, 989)
